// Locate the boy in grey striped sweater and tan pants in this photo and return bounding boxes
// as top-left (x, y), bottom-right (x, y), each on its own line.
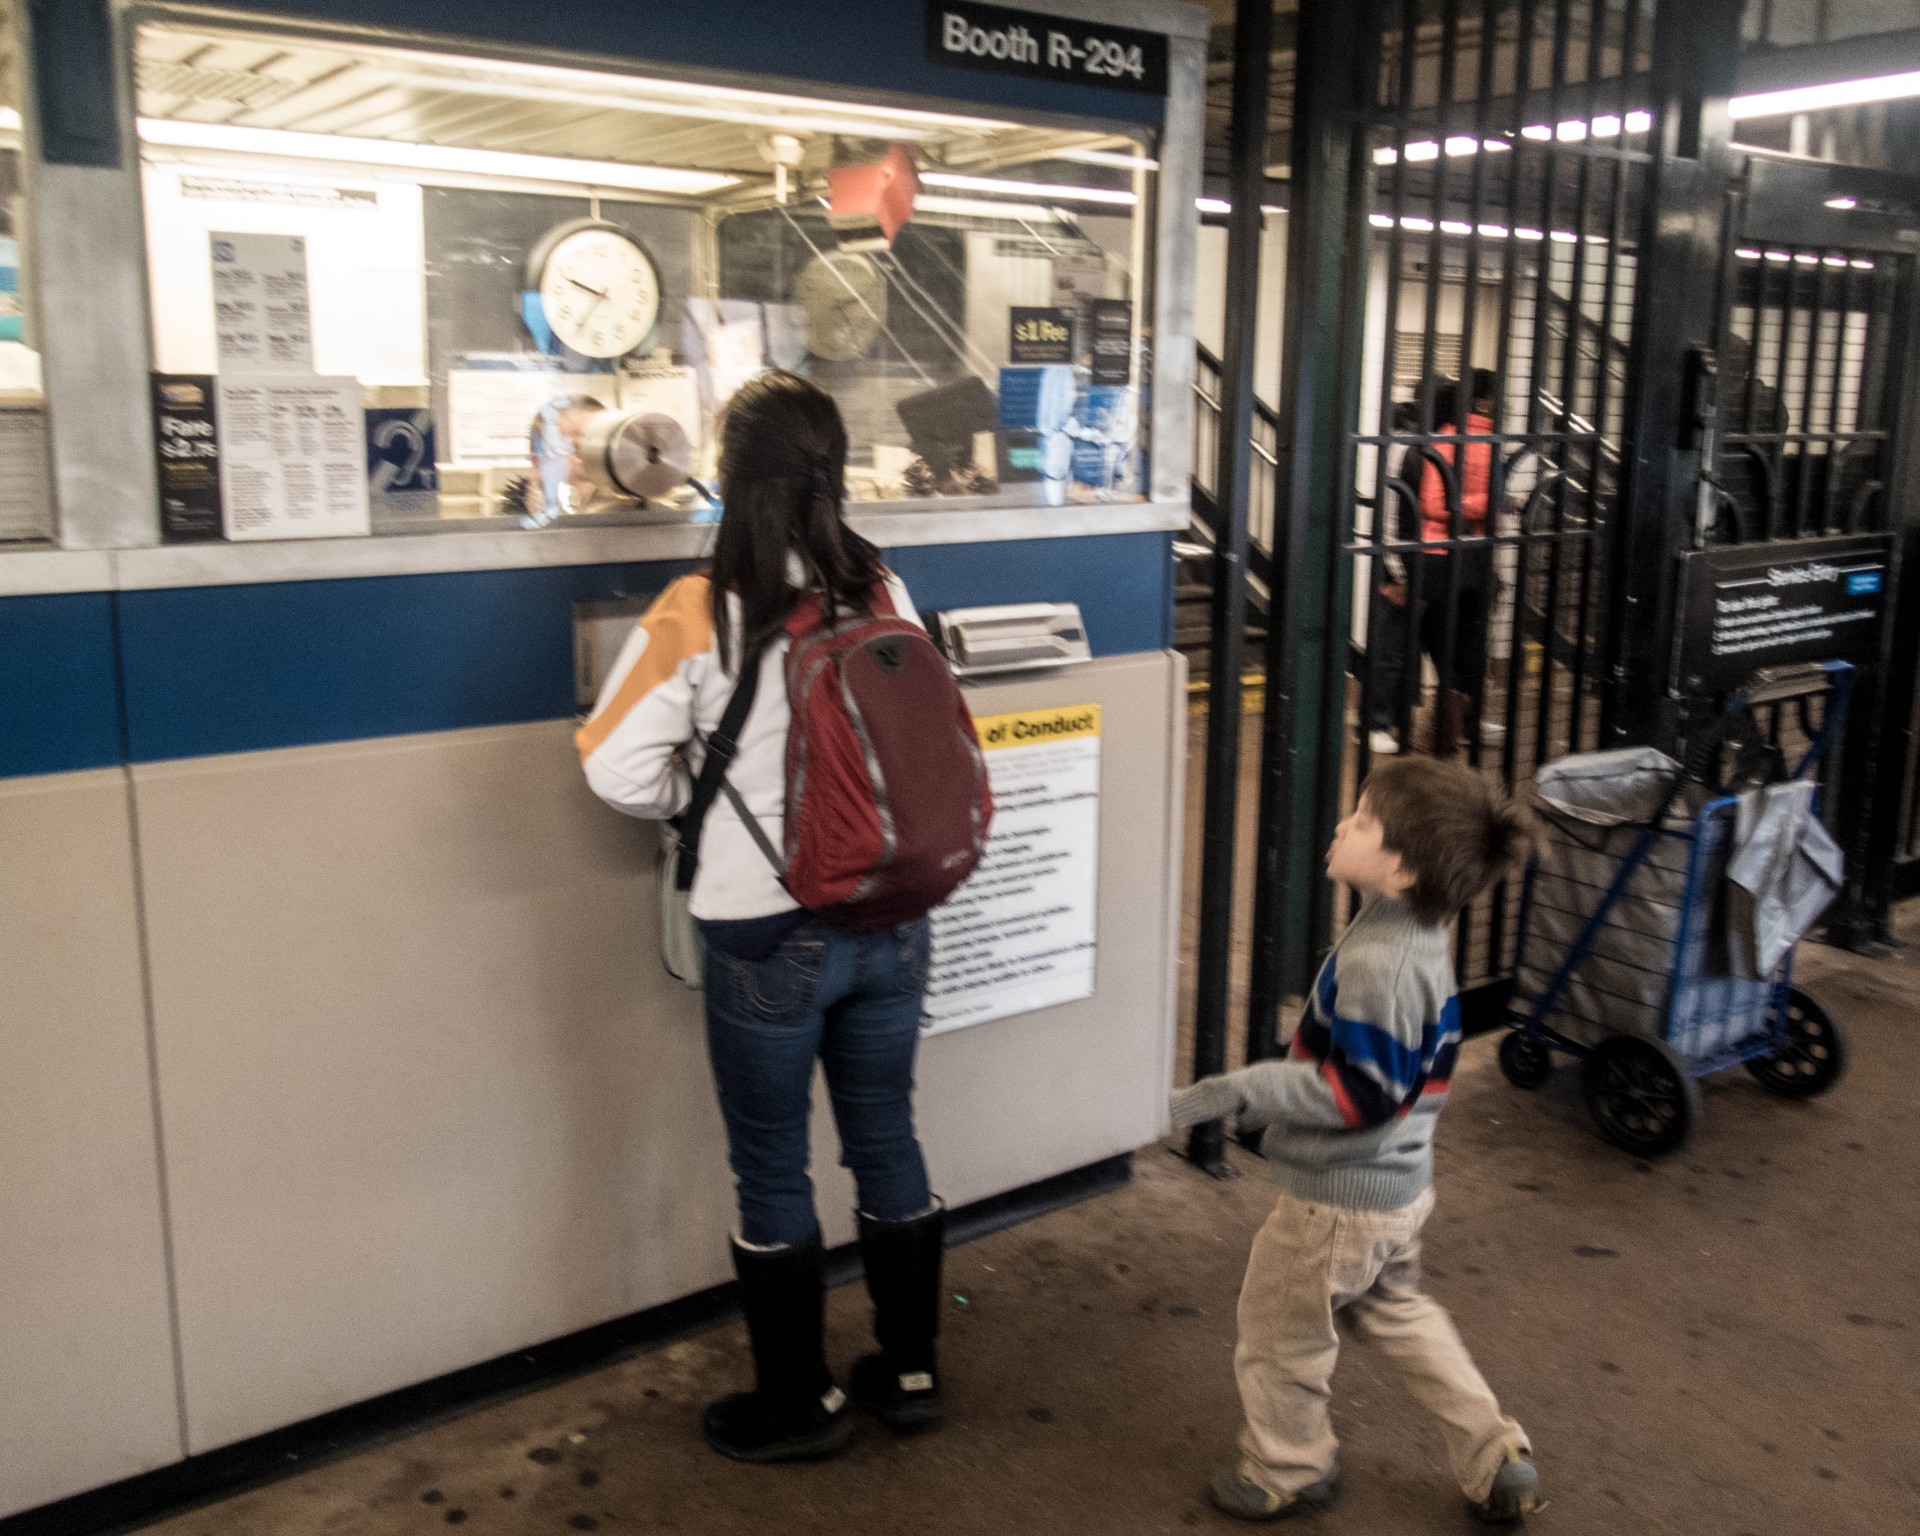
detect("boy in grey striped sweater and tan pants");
top-left (1173, 758), bottom-right (1540, 1521)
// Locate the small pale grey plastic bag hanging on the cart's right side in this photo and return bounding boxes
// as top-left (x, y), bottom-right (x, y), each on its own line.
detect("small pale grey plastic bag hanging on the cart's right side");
top-left (1726, 780), bottom-right (1845, 981)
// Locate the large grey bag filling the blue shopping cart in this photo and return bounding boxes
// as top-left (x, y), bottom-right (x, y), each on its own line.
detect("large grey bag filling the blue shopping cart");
top-left (1515, 747), bottom-right (1701, 1044)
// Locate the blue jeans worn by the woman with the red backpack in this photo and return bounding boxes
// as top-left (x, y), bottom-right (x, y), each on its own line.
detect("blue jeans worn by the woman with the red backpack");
top-left (707, 918), bottom-right (933, 1248)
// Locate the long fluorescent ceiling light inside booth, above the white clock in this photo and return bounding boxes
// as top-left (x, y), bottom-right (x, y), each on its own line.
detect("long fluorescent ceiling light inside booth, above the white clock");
top-left (140, 117), bottom-right (739, 198)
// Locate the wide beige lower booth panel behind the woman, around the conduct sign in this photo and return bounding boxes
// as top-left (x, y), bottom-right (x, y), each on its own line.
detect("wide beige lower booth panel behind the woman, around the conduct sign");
top-left (134, 653), bottom-right (1187, 1452)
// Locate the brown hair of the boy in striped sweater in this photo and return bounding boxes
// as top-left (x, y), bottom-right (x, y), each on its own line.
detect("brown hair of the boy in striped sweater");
top-left (1359, 756), bottom-right (1538, 924)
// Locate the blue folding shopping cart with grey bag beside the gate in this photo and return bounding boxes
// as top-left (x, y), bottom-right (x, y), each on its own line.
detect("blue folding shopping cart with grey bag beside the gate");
top-left (1500, 662), bottom-right (1853, 1156)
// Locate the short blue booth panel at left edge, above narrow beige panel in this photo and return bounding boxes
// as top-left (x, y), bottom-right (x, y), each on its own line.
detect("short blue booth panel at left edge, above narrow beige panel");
top-left (0, 591), bottom-right (121, 778)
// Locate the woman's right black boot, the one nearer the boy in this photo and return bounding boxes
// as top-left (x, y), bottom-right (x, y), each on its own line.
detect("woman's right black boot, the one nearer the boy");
top-left (852, 1202), bottom-right (947, 1428)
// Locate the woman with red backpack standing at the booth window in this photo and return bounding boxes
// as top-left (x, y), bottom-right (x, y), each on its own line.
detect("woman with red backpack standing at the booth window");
top-left (578, 372), bottom-right (993, 1461)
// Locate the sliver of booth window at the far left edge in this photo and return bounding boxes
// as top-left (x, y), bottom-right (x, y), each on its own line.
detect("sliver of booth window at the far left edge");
top-left (0, 0), bottom-right (54, 547)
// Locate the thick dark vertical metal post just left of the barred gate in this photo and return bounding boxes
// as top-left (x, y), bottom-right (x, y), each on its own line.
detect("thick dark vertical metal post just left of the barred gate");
top-left (1246, 4), bottom-right (1380, 1058)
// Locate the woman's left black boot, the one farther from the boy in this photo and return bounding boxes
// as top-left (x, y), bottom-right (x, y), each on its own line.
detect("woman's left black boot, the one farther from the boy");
top-left (701, 1236), bottom-right (854, 1461)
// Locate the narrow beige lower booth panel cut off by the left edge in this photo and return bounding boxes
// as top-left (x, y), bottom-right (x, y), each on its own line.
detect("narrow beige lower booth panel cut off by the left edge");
top-left (0, 768), bottom-right (184, 1517)
